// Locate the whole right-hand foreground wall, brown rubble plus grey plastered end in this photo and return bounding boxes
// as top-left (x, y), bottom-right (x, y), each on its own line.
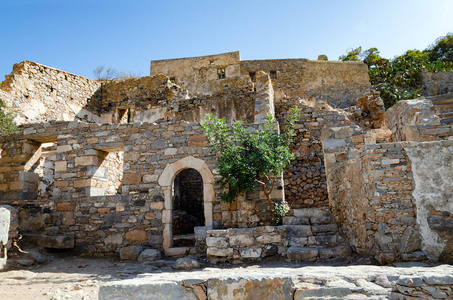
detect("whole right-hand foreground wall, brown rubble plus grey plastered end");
top-left (322, 119), bottom-right (453, 263)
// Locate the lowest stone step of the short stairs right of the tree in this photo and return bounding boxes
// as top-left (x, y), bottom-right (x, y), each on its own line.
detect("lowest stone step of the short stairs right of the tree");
top-left (286, 246), bottom-right (351, 262)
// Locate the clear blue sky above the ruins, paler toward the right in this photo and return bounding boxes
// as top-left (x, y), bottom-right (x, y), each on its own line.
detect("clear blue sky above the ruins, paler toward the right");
top-left (0, 0), bottom-right (453, 81)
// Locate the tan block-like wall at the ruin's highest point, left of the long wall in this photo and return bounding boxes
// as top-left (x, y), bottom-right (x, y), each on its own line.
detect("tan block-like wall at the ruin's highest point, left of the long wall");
top-left (150, 51), bottom-right (241, 94)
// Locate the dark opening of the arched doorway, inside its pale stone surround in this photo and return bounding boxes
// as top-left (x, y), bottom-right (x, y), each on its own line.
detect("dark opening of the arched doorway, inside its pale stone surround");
top-left (172, 169), bottom-right (205, 247)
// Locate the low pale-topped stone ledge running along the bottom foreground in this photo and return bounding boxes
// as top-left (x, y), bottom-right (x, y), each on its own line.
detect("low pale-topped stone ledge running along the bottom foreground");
top-left (99, 263), bottom-right (453, 300)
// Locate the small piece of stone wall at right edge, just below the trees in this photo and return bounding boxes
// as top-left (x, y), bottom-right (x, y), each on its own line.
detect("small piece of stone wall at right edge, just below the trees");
top-left (422, 71), bottom-right (453, 96)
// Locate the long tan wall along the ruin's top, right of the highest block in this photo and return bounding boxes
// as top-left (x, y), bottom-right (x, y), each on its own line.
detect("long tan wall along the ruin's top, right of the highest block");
top-left (241, 59), bottom-right (371, 108)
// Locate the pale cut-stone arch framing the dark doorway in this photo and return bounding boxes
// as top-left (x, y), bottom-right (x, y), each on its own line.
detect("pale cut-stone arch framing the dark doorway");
top-left (158, 156), bottom-right (215, 252)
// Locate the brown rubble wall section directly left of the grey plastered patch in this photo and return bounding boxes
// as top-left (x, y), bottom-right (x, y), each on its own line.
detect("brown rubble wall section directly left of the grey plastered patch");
top-left (323, 127), bottom-right (424, 263)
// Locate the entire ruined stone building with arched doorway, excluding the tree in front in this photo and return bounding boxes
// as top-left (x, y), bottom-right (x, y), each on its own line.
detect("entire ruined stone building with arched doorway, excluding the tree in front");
top-left (0, 52), bottom-right (453, 263)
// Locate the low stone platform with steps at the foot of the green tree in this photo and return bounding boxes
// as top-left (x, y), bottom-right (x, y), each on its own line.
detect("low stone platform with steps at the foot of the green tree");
top-left (206, 224), bottom-right (351, 263)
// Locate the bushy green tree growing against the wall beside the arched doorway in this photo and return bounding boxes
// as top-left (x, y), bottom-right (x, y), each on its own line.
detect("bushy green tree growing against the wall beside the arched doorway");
top-left (202, 107), bottom-right (300, 222)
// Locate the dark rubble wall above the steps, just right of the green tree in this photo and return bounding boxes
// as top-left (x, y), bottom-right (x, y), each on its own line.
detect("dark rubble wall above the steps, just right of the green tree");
top-left (276, 98), bottom-right (351, 208)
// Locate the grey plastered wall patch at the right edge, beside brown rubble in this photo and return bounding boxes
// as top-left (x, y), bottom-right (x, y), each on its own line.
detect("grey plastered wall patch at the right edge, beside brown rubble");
top-left (404, 141), bottom-right (453, 262)
